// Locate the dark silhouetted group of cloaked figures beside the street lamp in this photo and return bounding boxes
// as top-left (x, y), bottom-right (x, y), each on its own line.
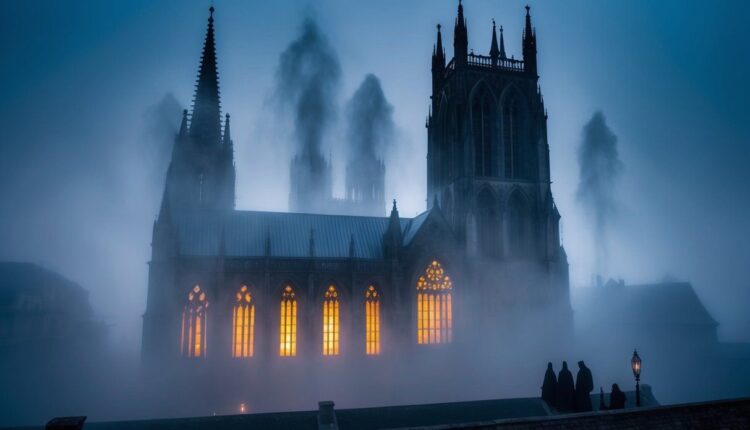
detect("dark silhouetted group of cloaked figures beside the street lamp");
top-left (542, 361), bottom-right (626, 412)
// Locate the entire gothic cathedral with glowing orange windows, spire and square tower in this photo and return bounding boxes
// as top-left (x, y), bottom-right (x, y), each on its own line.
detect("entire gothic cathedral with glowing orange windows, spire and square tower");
top-left (142, 2), bottom-right (572, 410)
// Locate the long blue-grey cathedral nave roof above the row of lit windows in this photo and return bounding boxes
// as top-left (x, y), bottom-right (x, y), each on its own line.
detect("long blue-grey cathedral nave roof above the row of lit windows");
top-left (172, 210), bottom-right (428, 259)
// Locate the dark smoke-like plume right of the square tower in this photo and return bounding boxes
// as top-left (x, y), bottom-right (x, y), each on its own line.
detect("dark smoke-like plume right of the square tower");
top-left (577, 111), bottom-right (623, 275)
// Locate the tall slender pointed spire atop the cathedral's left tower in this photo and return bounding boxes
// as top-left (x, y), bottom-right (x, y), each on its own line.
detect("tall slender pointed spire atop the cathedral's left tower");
top-left (190, 6), bottom-right (221, 145)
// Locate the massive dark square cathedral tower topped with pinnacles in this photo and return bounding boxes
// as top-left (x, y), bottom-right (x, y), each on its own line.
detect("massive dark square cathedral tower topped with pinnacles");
top-left (427, 2), bottom-right (560, 260)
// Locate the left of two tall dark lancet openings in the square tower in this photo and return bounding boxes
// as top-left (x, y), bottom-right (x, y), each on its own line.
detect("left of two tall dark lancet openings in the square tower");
top-left (471, 93), bottom-right (495, 176)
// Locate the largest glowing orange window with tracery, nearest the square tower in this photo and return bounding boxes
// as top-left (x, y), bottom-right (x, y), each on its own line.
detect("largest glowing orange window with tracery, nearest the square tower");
top-left (417, 261), bottom-right (453, 345)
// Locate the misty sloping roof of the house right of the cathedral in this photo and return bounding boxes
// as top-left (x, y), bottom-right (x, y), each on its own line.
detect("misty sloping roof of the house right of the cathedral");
top-left (571, 282), bottom-right (718, 327)
